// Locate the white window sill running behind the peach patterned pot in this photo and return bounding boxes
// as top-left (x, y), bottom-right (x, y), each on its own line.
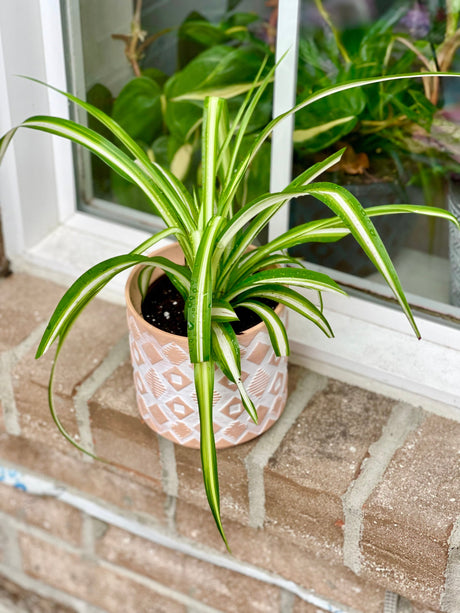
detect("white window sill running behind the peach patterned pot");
top-left (12, 213), bottom-right (460, 419)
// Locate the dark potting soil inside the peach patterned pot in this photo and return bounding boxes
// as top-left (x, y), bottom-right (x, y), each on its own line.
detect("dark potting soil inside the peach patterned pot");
top-left (141, 275), bottom-right (276, 336)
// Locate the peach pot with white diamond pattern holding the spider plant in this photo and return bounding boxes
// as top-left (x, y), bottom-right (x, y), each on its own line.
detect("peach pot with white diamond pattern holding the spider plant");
top-left (126, 244), bottom-right (287, 448)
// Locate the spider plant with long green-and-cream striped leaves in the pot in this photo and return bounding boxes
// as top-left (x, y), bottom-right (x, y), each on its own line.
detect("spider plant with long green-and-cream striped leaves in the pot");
top-left (0, 66), bottom-right (460, 543)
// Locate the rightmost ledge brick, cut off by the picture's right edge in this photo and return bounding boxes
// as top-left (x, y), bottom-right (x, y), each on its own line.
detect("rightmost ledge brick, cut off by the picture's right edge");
top-left (361, 415), bottom-right (460, 608)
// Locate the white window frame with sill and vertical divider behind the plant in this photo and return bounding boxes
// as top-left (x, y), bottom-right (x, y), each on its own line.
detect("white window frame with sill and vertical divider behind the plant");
top-left (0, 0), bottom-right (460, 419)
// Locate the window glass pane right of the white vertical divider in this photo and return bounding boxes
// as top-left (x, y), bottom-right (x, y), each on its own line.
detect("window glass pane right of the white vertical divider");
top-left (290, 0), bottom-right (460, 314)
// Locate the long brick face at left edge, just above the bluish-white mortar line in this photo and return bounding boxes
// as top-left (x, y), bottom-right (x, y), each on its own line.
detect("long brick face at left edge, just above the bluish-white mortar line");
top-left (0, 435), bottom-right (166, 523)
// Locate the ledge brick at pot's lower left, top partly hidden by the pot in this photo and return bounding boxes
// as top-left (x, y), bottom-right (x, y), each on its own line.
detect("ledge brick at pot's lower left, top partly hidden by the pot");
top-left (89, 363), bottom-right (161, 480)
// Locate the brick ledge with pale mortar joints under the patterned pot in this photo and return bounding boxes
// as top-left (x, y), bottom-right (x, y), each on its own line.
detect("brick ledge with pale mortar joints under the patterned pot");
top-left (0, 275), bottom-right (460, 613)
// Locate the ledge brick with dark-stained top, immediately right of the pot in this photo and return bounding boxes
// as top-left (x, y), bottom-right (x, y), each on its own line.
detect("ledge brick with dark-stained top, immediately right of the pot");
top-left (265, 381), bottom-right (394, 548)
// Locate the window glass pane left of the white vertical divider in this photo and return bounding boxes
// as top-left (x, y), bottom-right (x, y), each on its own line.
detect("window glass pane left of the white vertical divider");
top-left (72, 0), bottom-right (275, 230)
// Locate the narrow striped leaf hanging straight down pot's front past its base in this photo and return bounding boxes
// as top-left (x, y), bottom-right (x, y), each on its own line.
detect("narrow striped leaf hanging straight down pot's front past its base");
top-left (194, 360), bottom-right (229, 549)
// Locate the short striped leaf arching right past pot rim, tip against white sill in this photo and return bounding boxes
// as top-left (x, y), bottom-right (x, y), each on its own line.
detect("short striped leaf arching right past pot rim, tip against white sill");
top-left (235, 284), bottom-right (334, 337)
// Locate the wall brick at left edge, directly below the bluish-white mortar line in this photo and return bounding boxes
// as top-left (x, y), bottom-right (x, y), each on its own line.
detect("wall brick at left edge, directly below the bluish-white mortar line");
top-left (0, 485), bottom-right (82, 545)
